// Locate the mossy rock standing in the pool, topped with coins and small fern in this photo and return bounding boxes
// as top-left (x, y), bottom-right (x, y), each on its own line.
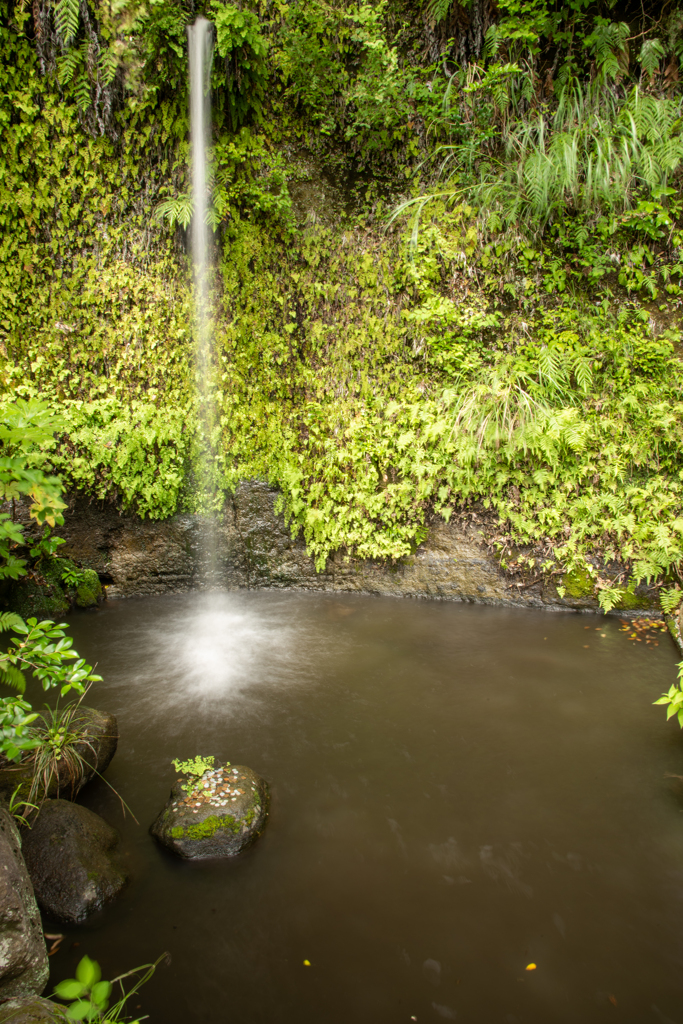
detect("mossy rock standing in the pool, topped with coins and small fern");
top-left (150, 765), bottom-right (268, 860)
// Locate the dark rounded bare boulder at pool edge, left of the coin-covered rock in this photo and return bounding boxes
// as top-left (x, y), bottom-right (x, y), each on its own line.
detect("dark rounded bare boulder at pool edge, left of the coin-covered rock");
top-left (24, 800), bottom-right (127, 924)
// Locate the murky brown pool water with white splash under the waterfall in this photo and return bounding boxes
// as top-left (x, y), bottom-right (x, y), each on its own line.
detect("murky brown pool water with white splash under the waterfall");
top-left (48, 593), bottom-right (683, 1024)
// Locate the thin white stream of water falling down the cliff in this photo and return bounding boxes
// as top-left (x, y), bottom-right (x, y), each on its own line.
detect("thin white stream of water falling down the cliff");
top-left (187, 17), bottom-right (216, 583)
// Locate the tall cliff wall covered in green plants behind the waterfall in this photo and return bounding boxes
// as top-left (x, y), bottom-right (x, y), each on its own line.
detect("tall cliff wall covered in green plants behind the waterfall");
top-left (0, 0), bottom-right (683, 607)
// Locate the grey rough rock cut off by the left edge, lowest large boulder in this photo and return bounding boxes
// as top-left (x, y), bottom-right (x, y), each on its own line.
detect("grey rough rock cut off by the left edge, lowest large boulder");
top-left (0, 807), bottom-right (49, 999)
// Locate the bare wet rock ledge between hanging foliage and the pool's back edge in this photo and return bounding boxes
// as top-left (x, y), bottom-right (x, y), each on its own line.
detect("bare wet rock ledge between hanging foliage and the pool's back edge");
top-left (15, 480), bottom-right (654, 610)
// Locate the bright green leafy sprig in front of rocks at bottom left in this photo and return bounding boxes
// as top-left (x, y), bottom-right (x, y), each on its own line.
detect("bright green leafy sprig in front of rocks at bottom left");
top-left (53, 953), bottom-right (168, 1024)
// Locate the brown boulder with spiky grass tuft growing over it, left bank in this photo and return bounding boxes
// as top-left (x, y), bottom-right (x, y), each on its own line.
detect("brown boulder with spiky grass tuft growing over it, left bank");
top-left (0, 708), bottom-right (119, 803)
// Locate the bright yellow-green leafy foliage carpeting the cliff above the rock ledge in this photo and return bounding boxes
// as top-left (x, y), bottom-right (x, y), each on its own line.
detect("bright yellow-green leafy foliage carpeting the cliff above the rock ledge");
top-left (0, 4), bottom-right (683, 600)
